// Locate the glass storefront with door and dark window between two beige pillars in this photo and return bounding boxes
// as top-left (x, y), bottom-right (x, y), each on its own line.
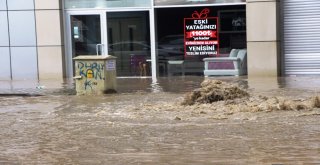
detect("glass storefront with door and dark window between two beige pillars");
top-left (64, 0), bottom-right (246, 77)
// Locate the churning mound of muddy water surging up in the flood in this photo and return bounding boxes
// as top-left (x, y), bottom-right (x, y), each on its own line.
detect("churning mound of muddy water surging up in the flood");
top-left (181, 80), bottom-right (320, 114)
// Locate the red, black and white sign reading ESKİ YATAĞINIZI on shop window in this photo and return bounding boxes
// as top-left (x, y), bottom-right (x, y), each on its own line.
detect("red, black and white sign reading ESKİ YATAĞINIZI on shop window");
top-left (184, 8), bottom-right (219, 56)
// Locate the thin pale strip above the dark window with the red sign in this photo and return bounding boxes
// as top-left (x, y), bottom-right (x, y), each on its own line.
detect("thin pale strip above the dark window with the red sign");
top-left (154, 0), bottom-right (246, 6)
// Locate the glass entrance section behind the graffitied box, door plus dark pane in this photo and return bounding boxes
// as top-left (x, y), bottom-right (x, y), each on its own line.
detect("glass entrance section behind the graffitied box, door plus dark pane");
top-left (66, 11), bottom-right (151, 77)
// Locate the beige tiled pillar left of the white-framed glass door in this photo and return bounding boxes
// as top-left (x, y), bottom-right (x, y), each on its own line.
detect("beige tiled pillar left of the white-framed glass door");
top-left (35, 0), bottom-right (64, 79)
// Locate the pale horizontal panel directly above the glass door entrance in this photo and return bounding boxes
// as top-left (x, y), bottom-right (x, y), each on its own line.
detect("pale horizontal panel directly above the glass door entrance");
top-left (65, 0), bottom-right (151, 9)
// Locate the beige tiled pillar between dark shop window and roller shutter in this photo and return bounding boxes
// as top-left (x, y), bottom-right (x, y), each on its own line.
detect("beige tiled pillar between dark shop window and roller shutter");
top-left (246, 0), bottom-right (280, 77)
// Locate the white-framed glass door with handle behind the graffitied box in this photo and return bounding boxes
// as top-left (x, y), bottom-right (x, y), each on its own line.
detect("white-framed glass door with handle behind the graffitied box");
top-left (66, 11), bottom-right (107, 77)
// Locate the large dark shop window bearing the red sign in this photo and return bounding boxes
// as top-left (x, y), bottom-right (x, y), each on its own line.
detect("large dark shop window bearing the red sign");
top-left (155, 5), bottom-right (247, 76)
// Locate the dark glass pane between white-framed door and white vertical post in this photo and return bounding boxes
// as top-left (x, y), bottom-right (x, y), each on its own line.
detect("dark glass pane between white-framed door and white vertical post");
top-left (107, 11), bottom-right (151, 76)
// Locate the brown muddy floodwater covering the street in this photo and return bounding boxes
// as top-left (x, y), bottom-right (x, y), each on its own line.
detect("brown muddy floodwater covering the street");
top-left (0, 76), bottom-right (320, 165)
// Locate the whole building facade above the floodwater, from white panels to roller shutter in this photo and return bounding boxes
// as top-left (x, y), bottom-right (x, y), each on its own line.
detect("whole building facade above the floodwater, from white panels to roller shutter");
top-left (0, 0), bottom-right (320, 80)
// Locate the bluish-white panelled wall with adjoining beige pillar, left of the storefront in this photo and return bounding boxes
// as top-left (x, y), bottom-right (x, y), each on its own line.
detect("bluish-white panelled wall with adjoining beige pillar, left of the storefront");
top-left (0, 0), bottom-right (64, 80)
